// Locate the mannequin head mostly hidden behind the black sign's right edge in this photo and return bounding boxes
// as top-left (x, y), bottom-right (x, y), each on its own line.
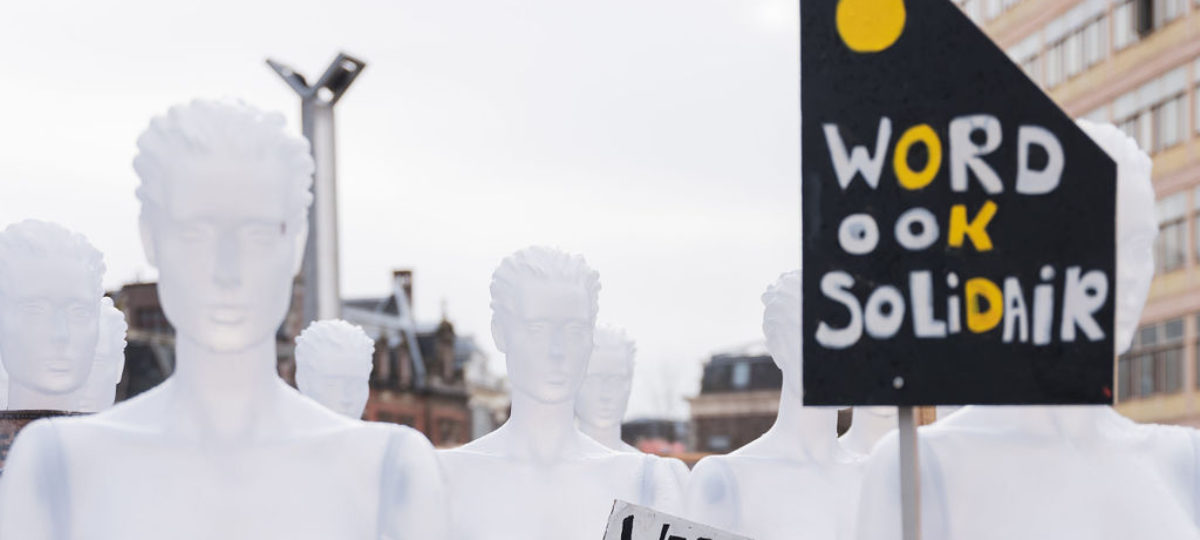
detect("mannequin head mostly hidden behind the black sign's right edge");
top-left (1079, 120), bottom-right (1158, 354)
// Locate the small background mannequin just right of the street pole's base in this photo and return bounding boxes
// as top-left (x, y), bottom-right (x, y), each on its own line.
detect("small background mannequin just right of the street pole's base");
top-left (295, 319), bottom-right (374, 420)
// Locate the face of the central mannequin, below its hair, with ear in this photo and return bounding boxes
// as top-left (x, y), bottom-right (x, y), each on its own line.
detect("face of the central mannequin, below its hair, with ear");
top-left (493, 280), bottom-right (595, 403)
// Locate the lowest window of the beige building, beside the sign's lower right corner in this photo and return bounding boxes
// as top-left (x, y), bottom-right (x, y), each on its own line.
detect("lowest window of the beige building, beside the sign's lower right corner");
top-left (1117, 319), bottom-right (1183, 400)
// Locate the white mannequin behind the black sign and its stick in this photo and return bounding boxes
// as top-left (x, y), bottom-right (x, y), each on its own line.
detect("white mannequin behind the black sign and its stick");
top-left (859, 121), bottom-right (1200, 540)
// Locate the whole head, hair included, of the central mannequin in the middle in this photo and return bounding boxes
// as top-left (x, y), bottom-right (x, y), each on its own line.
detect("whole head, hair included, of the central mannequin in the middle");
top-left (491, 247), bottom-right (600, 403)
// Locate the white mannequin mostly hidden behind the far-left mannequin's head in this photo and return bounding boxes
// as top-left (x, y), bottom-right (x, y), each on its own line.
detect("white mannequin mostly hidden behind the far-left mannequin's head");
top-left (72, 296), bottom-right (128, 413)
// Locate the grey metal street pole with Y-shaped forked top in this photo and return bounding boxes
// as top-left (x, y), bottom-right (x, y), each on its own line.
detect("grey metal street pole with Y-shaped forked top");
top-left (266, 53), bottom-right (366, 326)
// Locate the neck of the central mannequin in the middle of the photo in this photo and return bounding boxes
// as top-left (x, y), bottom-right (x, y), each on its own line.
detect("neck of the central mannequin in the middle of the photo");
top-left (505, 389), bottom-right (581, 462)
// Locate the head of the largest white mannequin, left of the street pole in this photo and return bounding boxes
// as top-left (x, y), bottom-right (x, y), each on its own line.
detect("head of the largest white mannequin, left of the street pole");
top-left (133, 101), bottom-right (313, 352)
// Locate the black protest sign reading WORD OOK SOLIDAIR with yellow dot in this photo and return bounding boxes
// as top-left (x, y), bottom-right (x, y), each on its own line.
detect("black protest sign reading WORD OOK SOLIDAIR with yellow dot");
top-left (800, 0), bottom-right (1116, 406)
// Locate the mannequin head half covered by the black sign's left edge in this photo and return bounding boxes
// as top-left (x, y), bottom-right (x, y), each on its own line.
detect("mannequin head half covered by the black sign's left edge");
top-left (762, 270), bottom-right (804, 396)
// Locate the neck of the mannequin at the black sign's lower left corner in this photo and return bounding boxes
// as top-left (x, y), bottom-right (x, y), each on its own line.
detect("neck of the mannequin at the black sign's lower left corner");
top-left (762, 384), bottom-right (839, 462)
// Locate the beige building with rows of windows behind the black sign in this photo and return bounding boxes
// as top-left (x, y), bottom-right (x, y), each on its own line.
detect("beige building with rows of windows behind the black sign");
top-left (955, 0), bottom-right (1200, 426)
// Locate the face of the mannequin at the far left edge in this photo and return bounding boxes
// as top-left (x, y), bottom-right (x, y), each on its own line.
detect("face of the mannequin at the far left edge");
top-left (0, 257), bottom-right (100, 395)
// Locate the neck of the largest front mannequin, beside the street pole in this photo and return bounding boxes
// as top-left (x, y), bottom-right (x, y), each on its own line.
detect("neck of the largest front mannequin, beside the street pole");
top-left (169, 334), bottom-right (284, 442)
